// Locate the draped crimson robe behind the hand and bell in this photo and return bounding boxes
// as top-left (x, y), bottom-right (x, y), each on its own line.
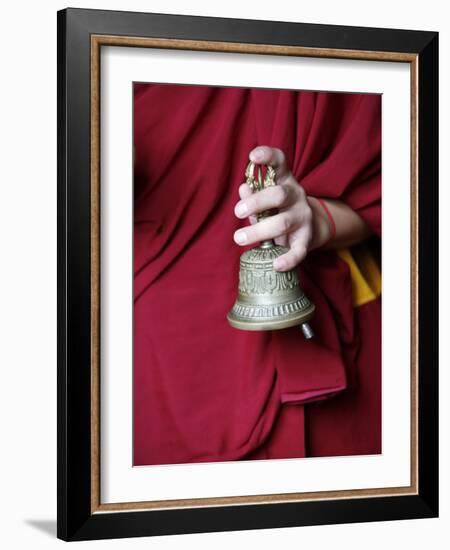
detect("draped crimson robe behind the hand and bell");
top-left (133, 84), bottom-right (381, 465)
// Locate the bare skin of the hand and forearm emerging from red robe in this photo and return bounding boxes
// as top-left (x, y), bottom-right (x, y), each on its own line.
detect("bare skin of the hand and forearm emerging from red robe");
top-left (234, 145), bottom-right (371, 271)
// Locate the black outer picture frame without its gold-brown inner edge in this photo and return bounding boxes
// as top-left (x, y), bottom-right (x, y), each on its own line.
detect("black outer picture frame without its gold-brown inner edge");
top-left (57, 9), bottom-right (438, 540)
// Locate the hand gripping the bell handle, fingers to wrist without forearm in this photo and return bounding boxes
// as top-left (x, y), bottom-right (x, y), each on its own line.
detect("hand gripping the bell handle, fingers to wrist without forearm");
top-left (234, 146), bottom-right (330, 271)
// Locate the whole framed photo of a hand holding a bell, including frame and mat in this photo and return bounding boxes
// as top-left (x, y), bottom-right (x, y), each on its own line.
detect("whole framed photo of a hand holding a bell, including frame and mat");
top-left (58, 9), bottom-right (438, 540)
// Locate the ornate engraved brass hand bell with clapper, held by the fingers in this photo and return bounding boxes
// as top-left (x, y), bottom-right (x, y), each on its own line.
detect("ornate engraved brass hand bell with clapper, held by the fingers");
top-left (227, 162), bottom-right (315, 339)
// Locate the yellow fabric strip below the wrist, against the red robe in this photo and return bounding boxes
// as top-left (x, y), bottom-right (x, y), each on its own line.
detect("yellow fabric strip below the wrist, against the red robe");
top-left (336, 245), bottom-right (381, 307)
